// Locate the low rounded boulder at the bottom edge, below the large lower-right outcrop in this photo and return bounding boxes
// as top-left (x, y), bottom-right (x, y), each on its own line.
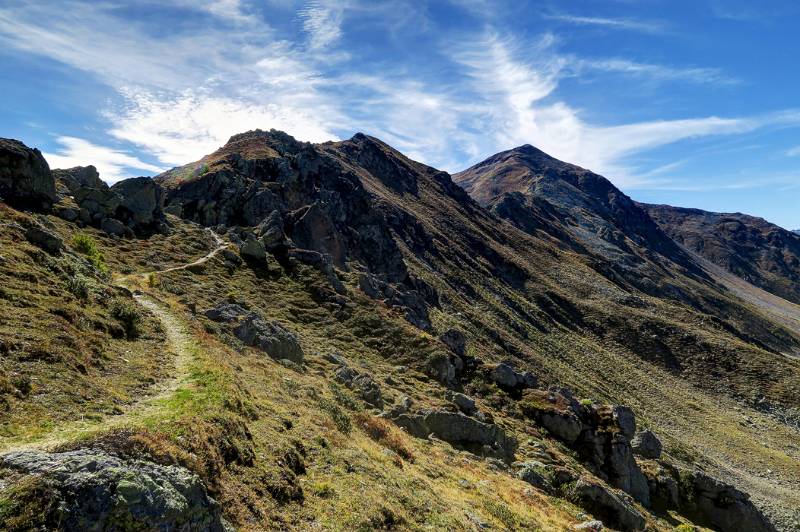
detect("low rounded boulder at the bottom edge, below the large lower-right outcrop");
top-left (568, 478), bottom-right (646, 531)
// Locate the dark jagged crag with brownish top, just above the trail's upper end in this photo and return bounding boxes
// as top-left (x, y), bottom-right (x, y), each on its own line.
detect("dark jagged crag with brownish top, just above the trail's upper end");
top-left (156, 130), bottom-right (436, 328)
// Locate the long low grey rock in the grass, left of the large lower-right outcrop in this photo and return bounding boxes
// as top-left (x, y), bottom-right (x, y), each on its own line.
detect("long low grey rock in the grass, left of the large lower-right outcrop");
top-left (394, 410), bottom-right (517, 458)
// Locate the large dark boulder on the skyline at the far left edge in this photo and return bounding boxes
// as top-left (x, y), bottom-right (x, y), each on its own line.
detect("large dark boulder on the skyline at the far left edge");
top-left (0, 138), bottom-right (57, 209)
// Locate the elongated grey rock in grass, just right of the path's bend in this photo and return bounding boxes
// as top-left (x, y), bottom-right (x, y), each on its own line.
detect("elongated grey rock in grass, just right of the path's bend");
top-left (203, 303), bottom-right (303, 364)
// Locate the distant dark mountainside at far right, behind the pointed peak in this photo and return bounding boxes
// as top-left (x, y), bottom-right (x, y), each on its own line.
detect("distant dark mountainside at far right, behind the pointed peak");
top-left (642, 205), bottom-right (800, 303)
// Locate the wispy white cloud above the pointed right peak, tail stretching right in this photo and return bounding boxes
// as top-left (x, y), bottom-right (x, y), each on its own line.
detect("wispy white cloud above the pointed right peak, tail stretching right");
top-left (458, 34), bottom-right (780, 186)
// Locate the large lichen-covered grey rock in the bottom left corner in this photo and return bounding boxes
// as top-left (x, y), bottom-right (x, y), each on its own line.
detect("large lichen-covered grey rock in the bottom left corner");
top-left (0, 450), bottom-right (226, 532)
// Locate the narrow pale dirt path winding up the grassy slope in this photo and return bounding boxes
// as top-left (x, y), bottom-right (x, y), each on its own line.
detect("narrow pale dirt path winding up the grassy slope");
top-left (0, 230), bottom-right (227, 453)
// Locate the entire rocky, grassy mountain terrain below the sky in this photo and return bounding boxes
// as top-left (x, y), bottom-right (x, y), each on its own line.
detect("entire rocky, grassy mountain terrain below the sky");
top-left (0, 130), bottom-right (800, 532)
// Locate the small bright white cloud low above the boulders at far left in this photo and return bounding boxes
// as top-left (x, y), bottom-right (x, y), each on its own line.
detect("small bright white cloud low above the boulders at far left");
top-left (43, 137), bottom-right (163, 183)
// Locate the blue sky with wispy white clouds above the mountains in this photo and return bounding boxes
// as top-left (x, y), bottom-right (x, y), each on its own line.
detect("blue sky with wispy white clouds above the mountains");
top-left (0, 0), bottom-right (800, 228)
